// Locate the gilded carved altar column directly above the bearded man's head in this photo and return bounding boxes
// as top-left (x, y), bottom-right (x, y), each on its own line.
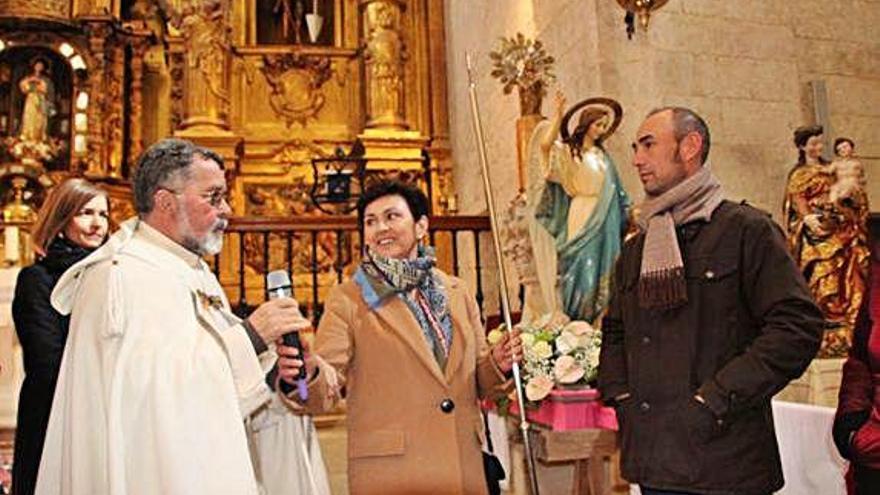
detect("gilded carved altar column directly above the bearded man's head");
top-left (180, 0), bottom-right (231, 135)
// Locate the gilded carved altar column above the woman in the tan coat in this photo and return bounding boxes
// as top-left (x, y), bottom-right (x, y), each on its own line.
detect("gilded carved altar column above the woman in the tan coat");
top-left (361, 0), bottom-right (407, 129)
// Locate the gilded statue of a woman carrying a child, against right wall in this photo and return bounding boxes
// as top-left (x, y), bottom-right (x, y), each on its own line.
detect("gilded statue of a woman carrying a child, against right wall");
top-left (783, 125), bottom-right (870, 358)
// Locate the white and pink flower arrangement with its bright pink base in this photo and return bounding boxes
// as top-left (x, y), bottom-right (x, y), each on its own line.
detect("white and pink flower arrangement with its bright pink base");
top-left (489, 314), bottom-right (617, 430)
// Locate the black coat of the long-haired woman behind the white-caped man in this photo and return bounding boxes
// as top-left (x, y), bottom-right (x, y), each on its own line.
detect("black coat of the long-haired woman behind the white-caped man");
top-left (12, 238), bottom-right (90, 495)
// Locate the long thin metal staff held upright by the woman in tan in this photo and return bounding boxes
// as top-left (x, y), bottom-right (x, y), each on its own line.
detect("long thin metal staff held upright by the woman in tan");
top-left (465, 53), bottom-right (539, 495)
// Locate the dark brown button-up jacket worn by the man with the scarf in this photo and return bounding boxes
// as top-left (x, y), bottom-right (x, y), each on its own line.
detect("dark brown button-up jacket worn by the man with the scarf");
top-left (599, 201), bottom-right (823, 494)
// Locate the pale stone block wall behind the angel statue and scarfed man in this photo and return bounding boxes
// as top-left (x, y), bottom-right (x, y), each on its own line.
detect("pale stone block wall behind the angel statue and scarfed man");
top-left (447, 0), bottom-right (880, 219)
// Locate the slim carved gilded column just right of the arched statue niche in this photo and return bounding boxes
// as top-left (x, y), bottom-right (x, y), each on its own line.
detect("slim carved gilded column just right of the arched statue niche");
top-left (85, 22), bottom-right (111, 177)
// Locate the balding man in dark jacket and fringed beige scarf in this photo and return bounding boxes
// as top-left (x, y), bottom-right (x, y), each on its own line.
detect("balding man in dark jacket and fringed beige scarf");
top-left (599, 107), bottom-right (823, 495)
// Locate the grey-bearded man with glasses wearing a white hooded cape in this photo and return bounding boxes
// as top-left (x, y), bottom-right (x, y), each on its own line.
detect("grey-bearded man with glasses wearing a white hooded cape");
top-left (36, 139), bottom-right (308, 495)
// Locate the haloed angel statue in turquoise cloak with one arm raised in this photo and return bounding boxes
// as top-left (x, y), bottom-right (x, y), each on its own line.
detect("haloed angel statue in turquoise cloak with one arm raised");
top-left (529, 92), bottom-right (630, 324)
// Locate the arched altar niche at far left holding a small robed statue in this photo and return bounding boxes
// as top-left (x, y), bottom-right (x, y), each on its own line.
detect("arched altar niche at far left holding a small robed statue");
top-left (0, 46), bottom-right (73, 170)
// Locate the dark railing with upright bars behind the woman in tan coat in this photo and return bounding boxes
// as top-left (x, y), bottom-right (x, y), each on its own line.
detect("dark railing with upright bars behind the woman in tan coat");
top-left (212, 216), bottom-right (494, 322)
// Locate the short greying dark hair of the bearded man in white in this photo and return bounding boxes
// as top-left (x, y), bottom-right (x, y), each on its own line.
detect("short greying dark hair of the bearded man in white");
top-left (133, 138), bottom-right (223, 217)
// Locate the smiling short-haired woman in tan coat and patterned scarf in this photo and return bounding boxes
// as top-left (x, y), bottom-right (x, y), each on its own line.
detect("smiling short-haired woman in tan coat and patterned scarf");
top-left (296, 182), bottom-right (521, 495)
